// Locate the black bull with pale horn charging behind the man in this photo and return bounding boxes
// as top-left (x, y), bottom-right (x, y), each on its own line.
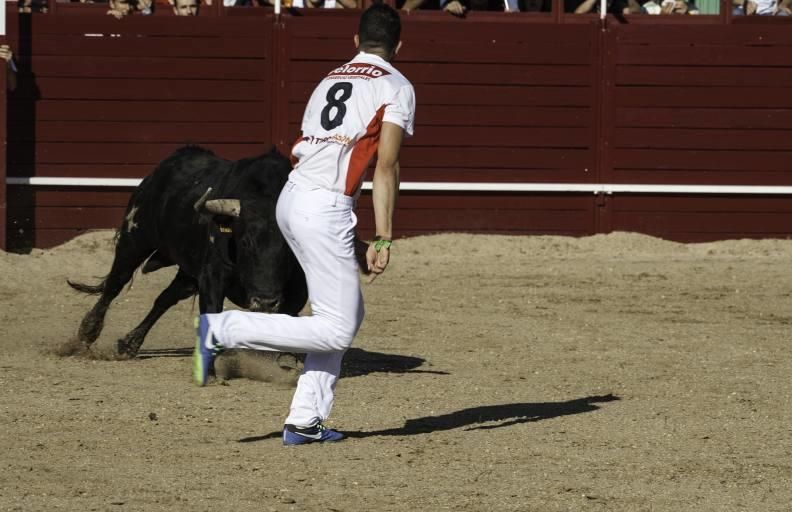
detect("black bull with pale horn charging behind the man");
top-left (69, 146), bottom-right (307, 357)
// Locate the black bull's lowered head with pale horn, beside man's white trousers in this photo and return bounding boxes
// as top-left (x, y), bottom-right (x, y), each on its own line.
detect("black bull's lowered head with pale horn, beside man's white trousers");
top-left (195, 152), bottom-right (297, 313)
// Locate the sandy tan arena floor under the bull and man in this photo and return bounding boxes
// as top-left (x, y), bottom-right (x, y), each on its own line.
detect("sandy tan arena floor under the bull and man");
top-left (0, 232), bottom-right (792, 512)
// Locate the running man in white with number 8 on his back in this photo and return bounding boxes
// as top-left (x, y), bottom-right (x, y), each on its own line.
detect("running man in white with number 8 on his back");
top-left (193, 3), bottom-right (415, 446)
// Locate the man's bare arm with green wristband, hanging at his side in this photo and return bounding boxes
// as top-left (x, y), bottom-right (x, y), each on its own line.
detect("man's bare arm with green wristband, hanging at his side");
top-left (366, 121), bottom-right (404, 283)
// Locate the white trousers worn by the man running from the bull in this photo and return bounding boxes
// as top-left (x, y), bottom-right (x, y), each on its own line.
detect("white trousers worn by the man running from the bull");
top-left (206, 181), bottom-right (364, 427)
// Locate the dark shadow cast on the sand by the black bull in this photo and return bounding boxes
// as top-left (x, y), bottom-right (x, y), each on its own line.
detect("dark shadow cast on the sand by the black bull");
top-left (137, 347), bottom-right (448, 378)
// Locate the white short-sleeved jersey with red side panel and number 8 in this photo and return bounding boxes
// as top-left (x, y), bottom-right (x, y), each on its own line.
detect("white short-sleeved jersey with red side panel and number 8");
top-left (291, 52), bottom-right (415, 197)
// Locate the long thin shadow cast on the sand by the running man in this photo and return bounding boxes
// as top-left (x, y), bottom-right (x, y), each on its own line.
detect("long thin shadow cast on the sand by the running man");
top-left (239, 393), bottom-right (621, 443)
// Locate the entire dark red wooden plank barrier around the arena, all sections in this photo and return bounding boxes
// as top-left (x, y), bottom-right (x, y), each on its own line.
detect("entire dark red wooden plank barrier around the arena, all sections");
top-left (0, 6), bottom-right (792, 247)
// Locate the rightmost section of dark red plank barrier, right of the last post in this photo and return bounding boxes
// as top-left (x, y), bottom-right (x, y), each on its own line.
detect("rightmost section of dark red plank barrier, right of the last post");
top-left (603, 23), bottom-right (792, 241)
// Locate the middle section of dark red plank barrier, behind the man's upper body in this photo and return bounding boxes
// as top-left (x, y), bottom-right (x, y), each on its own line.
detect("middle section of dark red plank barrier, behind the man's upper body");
top-left (284, 16), bottom-right (597, 235)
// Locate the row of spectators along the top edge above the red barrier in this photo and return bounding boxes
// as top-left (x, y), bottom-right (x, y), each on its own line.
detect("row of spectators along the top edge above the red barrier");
top-left (6, 0), bottom-right (792, 14)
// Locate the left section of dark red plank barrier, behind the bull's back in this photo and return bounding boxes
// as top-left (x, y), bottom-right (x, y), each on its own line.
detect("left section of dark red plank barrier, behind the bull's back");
top-left (8, 6), bottom-right (273, 246)
